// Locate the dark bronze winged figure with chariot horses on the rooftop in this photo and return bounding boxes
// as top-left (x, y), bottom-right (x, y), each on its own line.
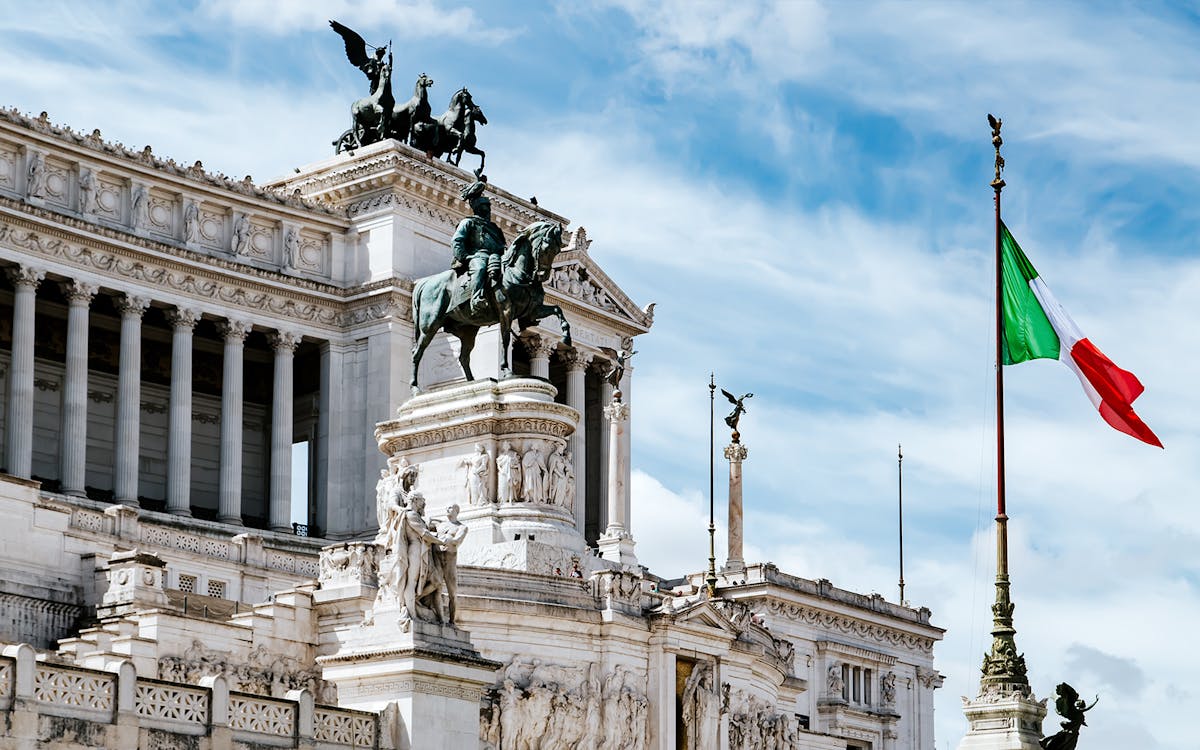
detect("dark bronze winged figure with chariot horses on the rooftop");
top-left (329, 20), bottom-right (487, 174)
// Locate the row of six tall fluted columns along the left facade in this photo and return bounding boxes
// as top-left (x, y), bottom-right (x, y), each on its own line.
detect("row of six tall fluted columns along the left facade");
top-left (5, 265), bottom-right (300, 530)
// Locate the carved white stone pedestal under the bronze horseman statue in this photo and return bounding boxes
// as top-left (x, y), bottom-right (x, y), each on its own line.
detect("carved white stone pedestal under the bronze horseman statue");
top-left (376, 378), bottom-right (587, 572)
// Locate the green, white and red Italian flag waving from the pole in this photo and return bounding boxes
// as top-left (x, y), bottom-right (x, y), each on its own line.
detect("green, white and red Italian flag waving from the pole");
top-left (1001, 224), bottom-right (1163, 448)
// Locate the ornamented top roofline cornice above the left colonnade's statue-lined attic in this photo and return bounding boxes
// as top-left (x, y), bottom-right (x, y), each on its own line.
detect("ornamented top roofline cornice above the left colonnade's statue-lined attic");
top-left (0, 108), bottom-right (346, 222)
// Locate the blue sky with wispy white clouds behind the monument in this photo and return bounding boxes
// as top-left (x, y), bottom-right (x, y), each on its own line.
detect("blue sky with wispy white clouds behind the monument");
top-left (0, 0), bottom-right (1200, 750)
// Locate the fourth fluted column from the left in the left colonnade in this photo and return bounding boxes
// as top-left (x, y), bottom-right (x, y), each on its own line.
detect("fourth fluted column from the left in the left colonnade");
top-left (167, 307), bottom-right (200, 516)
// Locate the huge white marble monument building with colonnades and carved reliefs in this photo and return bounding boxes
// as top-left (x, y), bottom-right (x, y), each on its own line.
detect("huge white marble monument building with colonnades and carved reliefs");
top-left (0, 106), bottom-right (942, 750)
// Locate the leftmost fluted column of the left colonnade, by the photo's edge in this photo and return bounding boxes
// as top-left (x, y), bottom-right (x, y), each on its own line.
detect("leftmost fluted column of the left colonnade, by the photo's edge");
top-left (5, 265), bottom-right (46, 479)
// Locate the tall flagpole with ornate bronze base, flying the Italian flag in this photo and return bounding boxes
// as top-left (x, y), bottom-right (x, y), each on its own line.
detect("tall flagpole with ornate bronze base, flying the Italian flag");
top-left (980, 114), bottom-right (1030, 695)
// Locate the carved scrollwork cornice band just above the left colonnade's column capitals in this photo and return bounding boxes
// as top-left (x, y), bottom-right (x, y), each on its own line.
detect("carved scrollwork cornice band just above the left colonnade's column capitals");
top-left (0, 206), bottom-right (409, 329)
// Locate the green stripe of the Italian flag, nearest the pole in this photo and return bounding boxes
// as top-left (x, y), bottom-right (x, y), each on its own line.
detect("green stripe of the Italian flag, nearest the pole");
top-left (1000, 224), bottom-right (1058, 365)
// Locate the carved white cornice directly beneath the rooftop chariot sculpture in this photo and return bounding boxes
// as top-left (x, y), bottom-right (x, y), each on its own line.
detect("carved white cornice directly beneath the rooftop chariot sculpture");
top-left (268, 140), bottom-right (570, 236)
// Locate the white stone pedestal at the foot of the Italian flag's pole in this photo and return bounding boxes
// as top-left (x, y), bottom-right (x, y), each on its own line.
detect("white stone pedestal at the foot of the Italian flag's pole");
top-left (958, 685), bottom-right (1046, 750)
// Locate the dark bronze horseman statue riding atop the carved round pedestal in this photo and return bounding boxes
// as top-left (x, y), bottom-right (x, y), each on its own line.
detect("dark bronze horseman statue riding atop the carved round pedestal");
top-left (412, 174), bottom-right (571, 394)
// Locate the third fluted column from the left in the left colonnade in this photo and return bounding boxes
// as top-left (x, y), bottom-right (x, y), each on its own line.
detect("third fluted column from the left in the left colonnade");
top-left (113, 294), bottom-right (150, 506)
